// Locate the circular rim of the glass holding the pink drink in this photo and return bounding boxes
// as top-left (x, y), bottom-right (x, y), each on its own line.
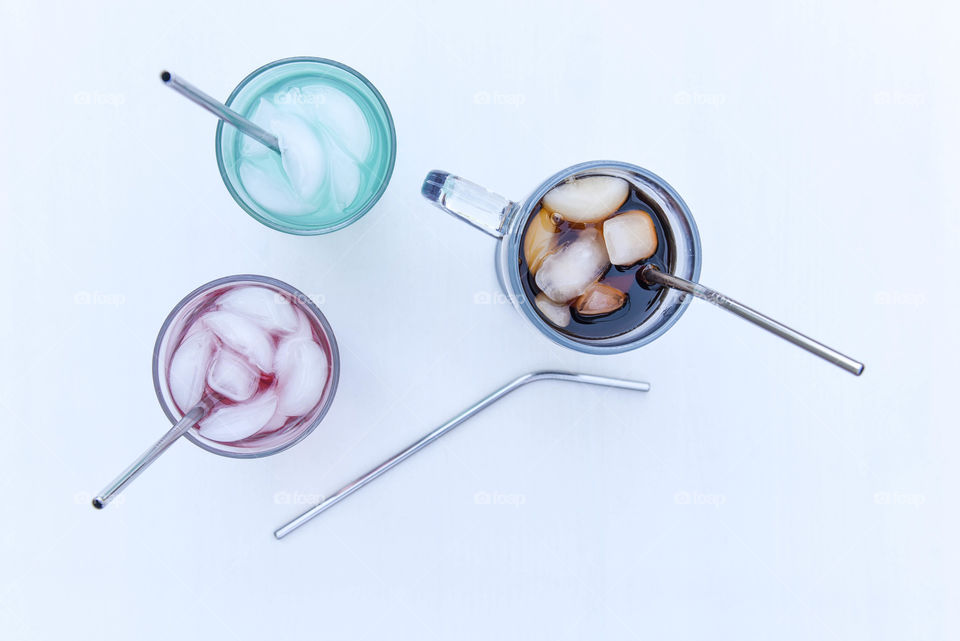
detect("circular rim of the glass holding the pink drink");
top-left (152, 274), bottom-right (340, 459)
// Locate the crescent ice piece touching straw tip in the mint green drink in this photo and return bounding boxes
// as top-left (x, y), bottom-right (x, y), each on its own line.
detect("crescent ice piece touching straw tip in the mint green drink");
top-left (270, 112), bottom-right (327, 201)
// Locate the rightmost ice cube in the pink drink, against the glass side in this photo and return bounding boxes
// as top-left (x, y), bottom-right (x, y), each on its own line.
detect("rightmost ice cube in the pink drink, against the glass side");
top-left (275, 338), bottom-right (327, 416)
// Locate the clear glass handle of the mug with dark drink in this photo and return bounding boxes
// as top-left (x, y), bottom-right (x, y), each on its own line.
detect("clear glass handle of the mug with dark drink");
top-left (420, 171), bottom-right (516, 238)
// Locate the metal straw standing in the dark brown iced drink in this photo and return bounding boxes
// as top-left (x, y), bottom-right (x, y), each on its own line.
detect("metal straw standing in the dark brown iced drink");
top-left (640, 265), bottom-right (863, 376)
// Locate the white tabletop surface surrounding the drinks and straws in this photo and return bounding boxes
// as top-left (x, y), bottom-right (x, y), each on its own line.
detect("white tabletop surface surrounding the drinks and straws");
top-left (0, 0), bottom-right (960, 640)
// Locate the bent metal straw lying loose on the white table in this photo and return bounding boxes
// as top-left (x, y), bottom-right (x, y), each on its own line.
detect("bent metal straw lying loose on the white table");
top-left (273, 372), bottom-right (650, 539)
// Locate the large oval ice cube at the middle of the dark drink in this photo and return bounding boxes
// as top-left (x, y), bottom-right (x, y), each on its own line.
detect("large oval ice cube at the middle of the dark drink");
top-left (536, 227), bottom-right (610, 303)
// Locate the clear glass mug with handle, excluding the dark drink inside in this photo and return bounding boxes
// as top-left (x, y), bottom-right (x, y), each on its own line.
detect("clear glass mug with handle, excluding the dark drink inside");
top-left (421, 160), bottom-right (700, 354)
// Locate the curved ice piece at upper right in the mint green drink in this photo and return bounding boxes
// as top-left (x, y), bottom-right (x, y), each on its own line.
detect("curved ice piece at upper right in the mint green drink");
top-left (300, 85), bottom-right (370, 162)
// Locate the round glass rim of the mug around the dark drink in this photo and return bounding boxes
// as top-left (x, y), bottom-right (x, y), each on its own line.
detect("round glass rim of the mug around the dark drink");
top-left (497, 160), bottom-right (702, 354)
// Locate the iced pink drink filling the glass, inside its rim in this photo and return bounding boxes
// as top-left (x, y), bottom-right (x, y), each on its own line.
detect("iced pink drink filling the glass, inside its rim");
top-left (164, 283), bottom-right (334, 450)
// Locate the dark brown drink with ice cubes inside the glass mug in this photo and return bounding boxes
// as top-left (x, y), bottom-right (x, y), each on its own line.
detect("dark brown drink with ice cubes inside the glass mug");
top-left (519, 176), bottom-right (670, 339)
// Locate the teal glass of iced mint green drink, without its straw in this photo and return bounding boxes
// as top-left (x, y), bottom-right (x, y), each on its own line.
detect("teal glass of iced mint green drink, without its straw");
top-left (217, 58), bottom-right (396, 235)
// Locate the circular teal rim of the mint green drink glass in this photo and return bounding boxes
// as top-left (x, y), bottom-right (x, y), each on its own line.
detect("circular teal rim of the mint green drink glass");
top-left (214, 56), bottom-right (397, 236)
